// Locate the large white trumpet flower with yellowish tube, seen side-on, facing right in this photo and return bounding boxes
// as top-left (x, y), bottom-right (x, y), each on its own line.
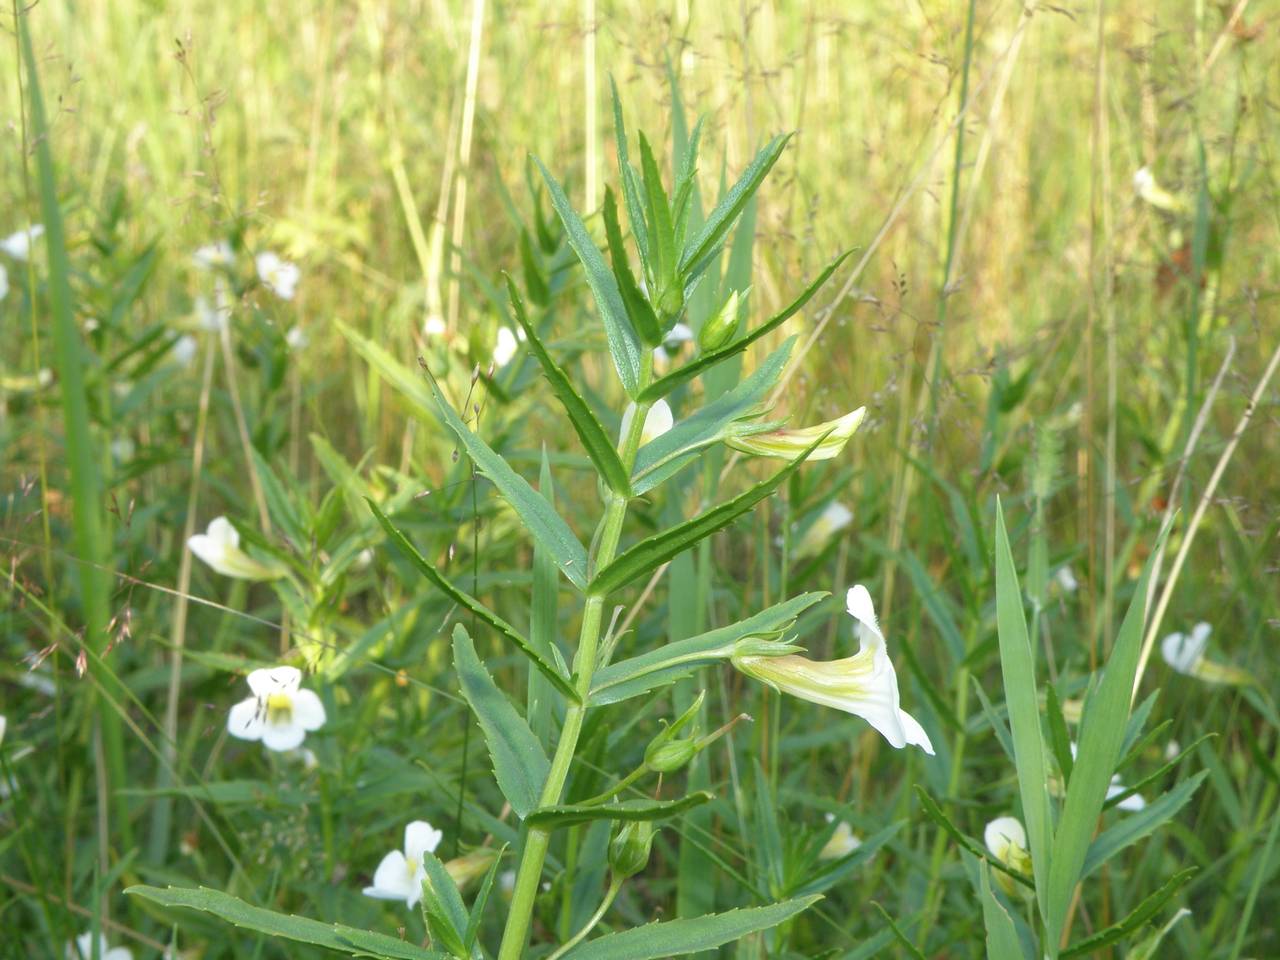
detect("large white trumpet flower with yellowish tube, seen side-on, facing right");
top-left (733, 584), bottom-right (933, 756)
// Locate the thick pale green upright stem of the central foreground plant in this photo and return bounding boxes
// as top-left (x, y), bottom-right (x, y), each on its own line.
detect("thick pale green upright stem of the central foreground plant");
top-left (498, 394), bottom-right (650, 960)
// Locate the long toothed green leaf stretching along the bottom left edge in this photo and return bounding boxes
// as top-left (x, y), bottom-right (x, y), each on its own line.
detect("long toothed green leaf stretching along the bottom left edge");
top-left (124, 884), bottom-right (445, 960)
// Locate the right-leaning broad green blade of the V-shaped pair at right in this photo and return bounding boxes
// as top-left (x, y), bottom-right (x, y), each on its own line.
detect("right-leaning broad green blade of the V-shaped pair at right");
top-left (1044, 522), bottom-right (1164, 941)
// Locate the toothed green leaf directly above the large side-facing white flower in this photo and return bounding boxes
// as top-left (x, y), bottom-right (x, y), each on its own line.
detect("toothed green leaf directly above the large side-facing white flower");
top-left (589, 591), bottom-right (829, 705)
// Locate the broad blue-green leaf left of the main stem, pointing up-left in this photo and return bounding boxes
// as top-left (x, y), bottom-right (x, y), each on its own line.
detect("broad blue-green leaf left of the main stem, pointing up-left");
top-left (453, 623), bottom-right (550, 819)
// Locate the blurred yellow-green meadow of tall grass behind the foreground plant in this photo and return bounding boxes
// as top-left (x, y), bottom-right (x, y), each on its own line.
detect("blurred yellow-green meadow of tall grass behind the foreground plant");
top-left (0, 0), bottom-right (1280, 959)
